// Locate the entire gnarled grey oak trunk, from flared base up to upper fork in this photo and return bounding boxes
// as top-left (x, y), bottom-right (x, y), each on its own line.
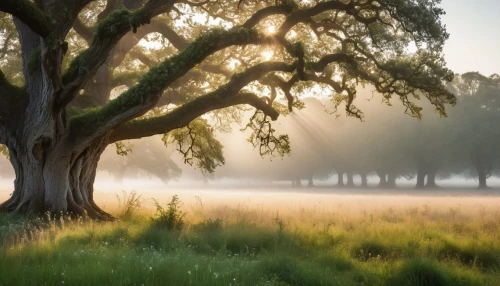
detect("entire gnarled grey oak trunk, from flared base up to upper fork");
top-left (0, 19), bottom-right (111, 219)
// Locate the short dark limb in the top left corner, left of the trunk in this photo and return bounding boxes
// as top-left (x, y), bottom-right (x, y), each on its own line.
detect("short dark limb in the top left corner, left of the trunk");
top-left (0, 0), bottom-right (53, 38)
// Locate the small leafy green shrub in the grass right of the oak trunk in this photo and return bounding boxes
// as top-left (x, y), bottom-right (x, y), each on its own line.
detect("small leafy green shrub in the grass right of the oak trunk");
top-left (152, 195), bottom-right (186, 230)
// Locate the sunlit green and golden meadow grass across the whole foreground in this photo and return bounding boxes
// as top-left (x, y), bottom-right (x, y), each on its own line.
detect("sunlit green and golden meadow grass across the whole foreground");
top-left (0, 195), bottom-right (500, 285)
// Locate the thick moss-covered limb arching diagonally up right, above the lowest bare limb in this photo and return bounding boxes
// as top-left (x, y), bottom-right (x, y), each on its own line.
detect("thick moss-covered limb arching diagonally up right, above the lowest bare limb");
top-left (72, 27), bottom-right (261, 143)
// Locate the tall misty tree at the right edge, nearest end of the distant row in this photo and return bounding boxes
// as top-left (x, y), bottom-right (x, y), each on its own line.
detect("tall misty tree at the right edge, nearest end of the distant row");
top-left (450, 72), bottom-right (500, 188)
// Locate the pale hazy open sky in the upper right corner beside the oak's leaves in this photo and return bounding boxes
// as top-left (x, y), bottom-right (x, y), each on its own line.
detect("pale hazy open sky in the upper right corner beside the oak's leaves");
top-left (442, 0), bottom-right (500, 75)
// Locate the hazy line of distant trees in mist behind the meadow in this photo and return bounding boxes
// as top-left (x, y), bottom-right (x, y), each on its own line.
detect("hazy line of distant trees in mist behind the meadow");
top-left (216, 72), bottom-right (500, 188)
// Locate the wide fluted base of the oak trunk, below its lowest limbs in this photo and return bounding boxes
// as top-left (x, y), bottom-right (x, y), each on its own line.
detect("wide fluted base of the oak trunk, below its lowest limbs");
top-left (0, 135), bottom-right (113, 220)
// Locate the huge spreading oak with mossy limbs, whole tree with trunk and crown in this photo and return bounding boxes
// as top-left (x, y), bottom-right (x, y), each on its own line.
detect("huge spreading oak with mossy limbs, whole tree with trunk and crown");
top-left (0, 0), bottom-right (455, 219)
